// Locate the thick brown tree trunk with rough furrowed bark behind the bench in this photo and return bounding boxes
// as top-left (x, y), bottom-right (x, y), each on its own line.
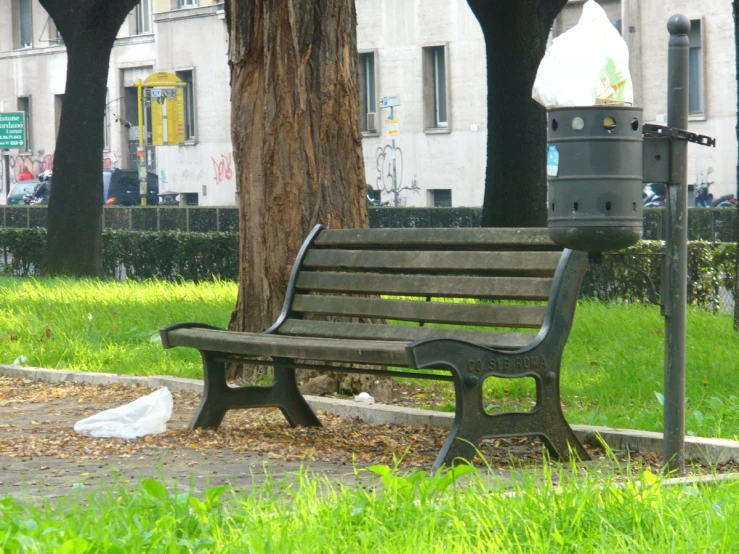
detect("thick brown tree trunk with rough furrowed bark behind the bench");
top-left (225, 0), bottom-right (368, 364)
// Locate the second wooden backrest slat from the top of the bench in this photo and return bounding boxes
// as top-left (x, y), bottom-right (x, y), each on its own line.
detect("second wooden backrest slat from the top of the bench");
top-left (303, 249), bottom-right (561, 276)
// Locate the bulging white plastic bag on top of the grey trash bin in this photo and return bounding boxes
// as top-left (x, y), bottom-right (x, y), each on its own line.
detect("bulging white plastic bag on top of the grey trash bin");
top-left (532, 0), bottom-right (634, 109)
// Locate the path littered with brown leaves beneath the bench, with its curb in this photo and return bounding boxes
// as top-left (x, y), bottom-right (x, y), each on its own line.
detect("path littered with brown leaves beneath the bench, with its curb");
top-left (0, 365), bottom-right (739, 498)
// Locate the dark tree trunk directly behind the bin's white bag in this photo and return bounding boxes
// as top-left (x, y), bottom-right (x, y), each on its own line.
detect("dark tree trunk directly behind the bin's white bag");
top-left (468, 0), bottom-right (567, 227)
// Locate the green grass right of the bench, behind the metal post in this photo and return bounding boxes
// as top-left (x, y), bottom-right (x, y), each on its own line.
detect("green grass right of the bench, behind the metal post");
top-left (562, 303), bottom-right (739, 439)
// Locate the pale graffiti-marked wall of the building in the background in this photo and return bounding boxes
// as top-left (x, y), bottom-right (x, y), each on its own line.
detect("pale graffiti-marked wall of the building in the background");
top-left (0, 0), bottom-right (737, 206)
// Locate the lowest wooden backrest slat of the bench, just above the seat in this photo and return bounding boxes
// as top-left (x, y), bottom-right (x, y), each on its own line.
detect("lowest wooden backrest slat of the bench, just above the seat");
top-left (278, 319), bottom-right (536, 350)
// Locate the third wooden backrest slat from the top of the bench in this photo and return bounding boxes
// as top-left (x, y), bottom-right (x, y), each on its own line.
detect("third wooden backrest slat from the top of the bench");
top-left (296, 271), bottom-right (552, 300)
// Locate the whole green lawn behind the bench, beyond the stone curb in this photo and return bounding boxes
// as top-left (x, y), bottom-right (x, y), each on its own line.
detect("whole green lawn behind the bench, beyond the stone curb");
top-left (0, 278), bottom-right (739, 439)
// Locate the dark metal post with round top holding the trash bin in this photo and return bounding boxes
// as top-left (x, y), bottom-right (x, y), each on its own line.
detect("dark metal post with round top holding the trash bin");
top-left (664, 15), bottom-right (690, 473)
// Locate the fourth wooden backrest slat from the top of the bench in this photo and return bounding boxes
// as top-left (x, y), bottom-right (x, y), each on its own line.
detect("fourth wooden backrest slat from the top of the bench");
top-left (292, 294), bottom-right (546, 328)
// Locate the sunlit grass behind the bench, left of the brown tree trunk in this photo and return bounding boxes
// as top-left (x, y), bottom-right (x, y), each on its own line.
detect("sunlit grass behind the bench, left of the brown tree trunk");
top-left (0, 277), bottom-right (237, 377)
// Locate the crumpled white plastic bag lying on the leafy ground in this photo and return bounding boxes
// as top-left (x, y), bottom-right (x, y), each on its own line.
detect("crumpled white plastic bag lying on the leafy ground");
top-left (74, 387), bottom-right (173, 439)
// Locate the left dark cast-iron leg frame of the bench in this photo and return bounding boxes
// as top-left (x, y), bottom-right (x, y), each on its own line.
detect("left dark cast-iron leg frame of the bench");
top-left (190, 352), bottom-right (321, 429)
